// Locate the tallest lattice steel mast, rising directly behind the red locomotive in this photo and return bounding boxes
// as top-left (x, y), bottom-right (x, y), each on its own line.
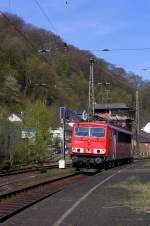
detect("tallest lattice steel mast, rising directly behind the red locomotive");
top-left (88, 58), bottom-right (95, 120)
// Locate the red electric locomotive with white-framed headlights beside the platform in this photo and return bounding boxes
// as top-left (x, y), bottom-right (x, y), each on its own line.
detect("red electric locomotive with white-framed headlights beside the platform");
top-left (71, 122), bottom-right (133, 169)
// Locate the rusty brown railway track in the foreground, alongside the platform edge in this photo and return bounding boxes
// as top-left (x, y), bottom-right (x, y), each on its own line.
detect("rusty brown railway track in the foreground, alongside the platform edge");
top-left (0, 173), bottom-right (86, 222)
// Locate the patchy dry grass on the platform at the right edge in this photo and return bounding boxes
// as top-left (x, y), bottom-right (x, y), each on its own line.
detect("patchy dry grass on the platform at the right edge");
top-left (115, 176), bottom-right (150, 213)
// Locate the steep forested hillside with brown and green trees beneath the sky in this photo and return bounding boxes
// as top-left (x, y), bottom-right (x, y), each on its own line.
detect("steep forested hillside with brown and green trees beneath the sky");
top-left (0, 14), bottom-right (150, 126)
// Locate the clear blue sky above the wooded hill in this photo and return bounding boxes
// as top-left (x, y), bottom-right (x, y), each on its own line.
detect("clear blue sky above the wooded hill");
top-left (0, 0), bottom-right (150, 80)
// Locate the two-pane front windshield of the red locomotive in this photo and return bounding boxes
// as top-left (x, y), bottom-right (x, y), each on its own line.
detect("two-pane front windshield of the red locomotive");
top-left (75, 127), bottom-right (105, 138)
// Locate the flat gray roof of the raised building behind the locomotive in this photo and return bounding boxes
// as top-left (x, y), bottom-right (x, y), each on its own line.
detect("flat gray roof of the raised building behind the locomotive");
top-left (95, 103), bottom-right (130, 109)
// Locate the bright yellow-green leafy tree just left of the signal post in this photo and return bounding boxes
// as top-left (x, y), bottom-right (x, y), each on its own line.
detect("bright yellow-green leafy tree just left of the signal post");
top-left (24, 101), bottom-right (50, 161)
